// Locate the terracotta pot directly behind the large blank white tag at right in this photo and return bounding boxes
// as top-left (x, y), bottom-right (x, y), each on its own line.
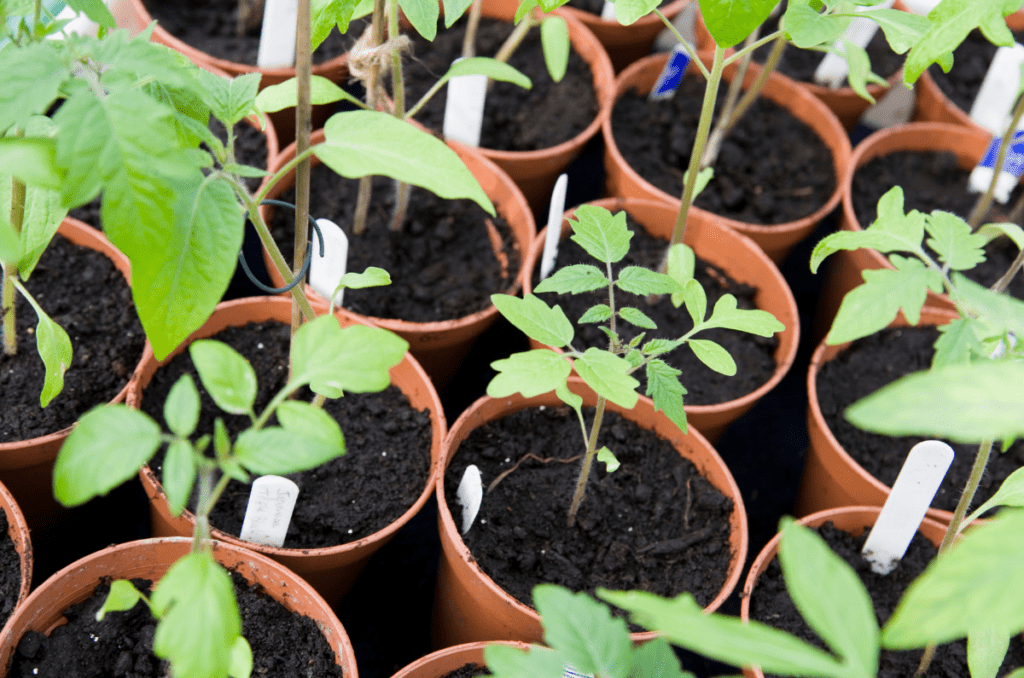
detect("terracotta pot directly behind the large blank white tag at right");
top-left (795, 306), bottom-right (957, 524)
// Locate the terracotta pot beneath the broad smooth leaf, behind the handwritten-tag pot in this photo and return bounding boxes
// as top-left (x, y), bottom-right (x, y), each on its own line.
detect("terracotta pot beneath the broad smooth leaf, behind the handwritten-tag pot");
top-left (260, 130), bottom-right (537, 390)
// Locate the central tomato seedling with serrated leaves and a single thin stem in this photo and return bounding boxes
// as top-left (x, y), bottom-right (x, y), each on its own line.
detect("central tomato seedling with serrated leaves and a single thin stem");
top-left (487, 205), bottom-right (785, 524)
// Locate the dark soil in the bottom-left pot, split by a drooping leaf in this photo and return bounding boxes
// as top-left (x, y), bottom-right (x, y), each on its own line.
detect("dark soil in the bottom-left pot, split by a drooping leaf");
top-left (9, 573), bottom-right (343, 678)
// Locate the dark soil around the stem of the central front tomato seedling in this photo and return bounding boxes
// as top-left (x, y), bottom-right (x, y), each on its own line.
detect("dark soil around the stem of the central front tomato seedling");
top-left (444, 407), bottom-right (733, 605)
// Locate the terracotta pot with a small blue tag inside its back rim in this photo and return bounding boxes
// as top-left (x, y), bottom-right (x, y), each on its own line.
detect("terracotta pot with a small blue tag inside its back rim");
top-left (601, 54), bottom-right (851, 263)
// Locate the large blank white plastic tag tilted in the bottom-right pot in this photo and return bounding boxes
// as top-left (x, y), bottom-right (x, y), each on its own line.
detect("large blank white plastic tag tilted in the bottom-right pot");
top-left (861, 440), bottom-right (953, 575)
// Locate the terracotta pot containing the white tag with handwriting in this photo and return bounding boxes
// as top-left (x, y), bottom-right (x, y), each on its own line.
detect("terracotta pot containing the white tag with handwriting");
top-left (128, 297), bottom-right (447, 604)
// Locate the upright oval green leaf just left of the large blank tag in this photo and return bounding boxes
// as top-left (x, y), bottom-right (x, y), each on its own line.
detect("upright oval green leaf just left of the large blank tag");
top-left (778, 521), bottom-right (879, 676)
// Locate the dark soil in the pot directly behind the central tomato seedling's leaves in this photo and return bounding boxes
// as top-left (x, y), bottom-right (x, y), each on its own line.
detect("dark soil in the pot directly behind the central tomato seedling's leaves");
top-left (532, 215), bottom-right (778, 405)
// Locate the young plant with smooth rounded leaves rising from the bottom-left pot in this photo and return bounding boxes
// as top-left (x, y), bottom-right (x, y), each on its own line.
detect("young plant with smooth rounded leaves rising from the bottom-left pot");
top-left (53, 315), bottom-right (409, 678)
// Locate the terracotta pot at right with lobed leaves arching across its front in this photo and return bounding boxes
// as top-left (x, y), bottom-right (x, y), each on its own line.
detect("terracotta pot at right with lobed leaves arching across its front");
top-left (815, 123), bottom-right (991, 339)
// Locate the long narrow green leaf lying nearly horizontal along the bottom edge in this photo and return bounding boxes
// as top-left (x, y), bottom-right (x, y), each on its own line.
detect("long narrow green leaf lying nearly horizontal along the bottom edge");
top-left (597, 589), bottom-right (847, 678)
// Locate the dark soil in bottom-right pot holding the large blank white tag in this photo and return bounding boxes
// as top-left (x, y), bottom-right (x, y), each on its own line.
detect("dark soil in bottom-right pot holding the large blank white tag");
top-left (751, 522), bottom-right (1024, 678)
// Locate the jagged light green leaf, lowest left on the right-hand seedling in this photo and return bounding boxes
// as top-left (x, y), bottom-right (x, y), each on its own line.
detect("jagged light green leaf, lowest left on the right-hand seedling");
top-left (827, 254), bottom-right (943, 345)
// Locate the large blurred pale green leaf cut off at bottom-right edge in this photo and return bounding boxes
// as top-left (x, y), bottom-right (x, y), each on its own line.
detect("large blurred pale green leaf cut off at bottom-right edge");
top-left (882, 509), bottom-right (1024, 649)
